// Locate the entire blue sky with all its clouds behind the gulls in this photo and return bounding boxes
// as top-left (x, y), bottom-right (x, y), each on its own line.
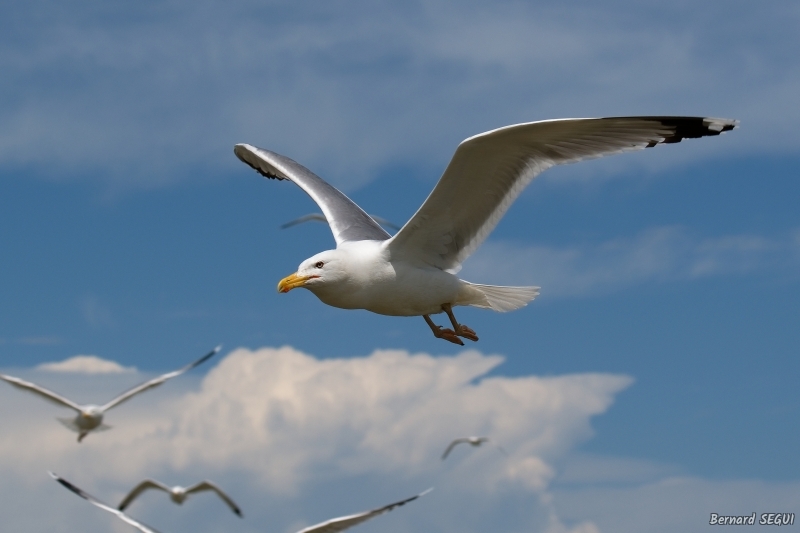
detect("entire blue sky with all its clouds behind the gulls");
top-left (0, 0), bottom-right (800, 533)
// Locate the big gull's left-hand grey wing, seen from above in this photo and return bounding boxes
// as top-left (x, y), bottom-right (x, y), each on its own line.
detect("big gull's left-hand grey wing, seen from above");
top-left (233, 144), bottom-right (390, 245)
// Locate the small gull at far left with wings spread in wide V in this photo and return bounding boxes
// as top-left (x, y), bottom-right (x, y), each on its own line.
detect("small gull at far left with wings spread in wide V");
top-left (0, 345), bottom-right (222, 442)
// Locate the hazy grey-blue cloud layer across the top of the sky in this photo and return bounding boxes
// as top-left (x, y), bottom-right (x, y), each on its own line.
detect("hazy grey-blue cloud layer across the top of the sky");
top-left (0, 0), bottom-right (800, 187)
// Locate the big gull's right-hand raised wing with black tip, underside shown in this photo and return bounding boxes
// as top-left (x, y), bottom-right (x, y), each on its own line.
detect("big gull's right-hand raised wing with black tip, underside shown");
top-left (387, 117), bottom-right (738, 272)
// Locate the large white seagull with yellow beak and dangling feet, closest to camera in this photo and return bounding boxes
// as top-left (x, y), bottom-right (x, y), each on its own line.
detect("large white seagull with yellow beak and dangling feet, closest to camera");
top-left (234, 117), bottom-right (738, 345)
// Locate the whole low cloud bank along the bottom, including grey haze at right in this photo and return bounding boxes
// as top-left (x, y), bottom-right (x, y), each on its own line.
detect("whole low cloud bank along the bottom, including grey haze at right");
top-left (0, 347), bottom-right (800, 533)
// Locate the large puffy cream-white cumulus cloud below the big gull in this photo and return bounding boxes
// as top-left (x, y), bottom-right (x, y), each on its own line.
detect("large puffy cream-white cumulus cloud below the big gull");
top-left (0, 347), bottom-right (631, 533)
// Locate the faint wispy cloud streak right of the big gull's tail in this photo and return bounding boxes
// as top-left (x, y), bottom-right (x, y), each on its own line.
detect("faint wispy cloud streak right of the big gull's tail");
top-left (460, 226), bottom-right (800, 297)
